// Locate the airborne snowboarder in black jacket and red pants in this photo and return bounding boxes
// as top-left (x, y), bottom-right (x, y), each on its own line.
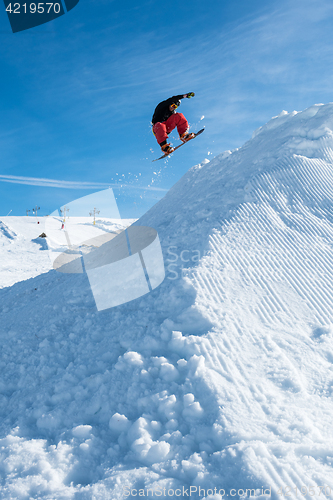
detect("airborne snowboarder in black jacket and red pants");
top-left (151, 92), bottom-right (195, 154)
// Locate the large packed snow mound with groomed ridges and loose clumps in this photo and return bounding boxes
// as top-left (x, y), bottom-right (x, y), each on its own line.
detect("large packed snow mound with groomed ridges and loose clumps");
top-left (0, 104), bottom-right (333, 500)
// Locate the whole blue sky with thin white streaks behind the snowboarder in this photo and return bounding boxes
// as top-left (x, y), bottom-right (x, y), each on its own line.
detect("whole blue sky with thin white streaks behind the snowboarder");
top-left (0, 0), bottom-right (333, 217)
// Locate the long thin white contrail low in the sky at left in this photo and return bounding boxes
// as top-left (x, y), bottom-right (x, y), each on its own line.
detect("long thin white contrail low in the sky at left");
top-left (0, 175), bottom-right (168, 192)
